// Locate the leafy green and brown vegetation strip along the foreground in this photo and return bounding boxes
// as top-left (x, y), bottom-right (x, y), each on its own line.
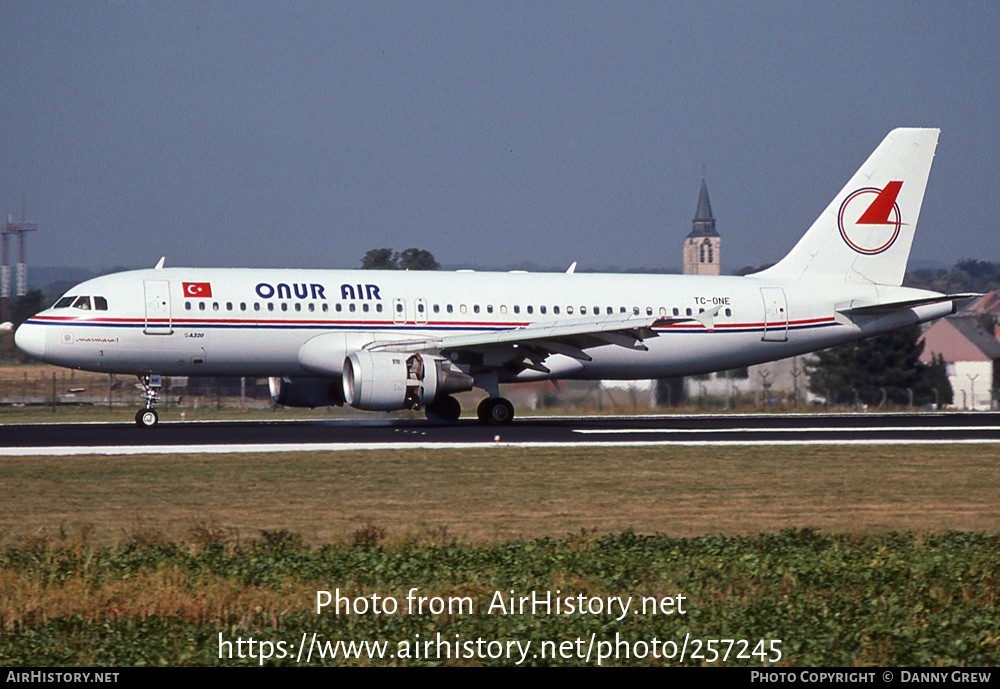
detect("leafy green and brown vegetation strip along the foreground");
top-left (0, 525), bottom-right (1000, 667)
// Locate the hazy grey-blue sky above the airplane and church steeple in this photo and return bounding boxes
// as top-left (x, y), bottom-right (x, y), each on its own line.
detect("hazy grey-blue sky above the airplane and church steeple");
top-left (0, 0), bottom-right (1000, 272)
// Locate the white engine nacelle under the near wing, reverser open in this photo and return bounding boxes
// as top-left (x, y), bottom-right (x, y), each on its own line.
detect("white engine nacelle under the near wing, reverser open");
top-left (344, 350), bottom-right (473, 411)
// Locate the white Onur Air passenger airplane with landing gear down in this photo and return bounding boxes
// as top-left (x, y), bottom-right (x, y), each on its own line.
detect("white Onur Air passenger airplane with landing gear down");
top-left (15, 128), bottom-right (974, 427)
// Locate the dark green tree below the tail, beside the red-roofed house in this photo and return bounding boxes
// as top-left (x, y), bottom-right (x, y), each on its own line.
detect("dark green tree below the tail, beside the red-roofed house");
top-left (807, 326), bottom-right (951, 405)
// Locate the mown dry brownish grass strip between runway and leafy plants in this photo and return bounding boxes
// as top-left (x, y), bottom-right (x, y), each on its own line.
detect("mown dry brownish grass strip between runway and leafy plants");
top-left (0, 445), bottom-right (1000, 545)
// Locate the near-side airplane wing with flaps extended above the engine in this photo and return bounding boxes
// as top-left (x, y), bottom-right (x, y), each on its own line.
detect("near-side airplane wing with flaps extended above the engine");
top-left (366, 314), bottom-right (694, 371)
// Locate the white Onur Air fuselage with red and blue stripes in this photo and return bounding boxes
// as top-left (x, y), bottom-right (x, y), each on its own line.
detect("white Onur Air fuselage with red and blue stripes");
top-left (17, 268), bottom-right (952, 382)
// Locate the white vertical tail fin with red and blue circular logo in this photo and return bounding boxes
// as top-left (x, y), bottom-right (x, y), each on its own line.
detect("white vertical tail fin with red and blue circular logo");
top-left (757, 129), bottom-right (940, 285)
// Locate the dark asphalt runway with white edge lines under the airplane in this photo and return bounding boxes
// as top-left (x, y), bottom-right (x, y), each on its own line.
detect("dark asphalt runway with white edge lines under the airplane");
top-left (0, 412), bottom-right (1000, 456)
